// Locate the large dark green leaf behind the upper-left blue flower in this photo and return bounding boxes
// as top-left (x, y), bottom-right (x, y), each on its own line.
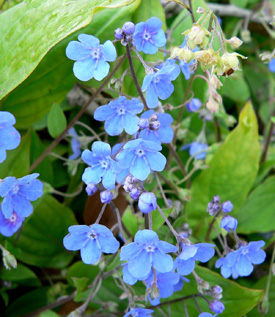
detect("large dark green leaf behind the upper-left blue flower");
top-left (0, 0), bottom-right (140, 128)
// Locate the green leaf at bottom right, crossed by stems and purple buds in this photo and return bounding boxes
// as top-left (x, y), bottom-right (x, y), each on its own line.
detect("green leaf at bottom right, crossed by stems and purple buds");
top-left (152, 267), bottom-right (263, 317)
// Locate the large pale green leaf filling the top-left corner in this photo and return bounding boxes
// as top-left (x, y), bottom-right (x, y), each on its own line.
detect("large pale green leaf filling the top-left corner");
top-left (0, 0), bottom-right (137, 99)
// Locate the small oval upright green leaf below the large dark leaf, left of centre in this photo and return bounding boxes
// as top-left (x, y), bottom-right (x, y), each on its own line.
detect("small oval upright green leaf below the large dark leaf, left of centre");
top-left (48, 104), bottom-right (67, 138)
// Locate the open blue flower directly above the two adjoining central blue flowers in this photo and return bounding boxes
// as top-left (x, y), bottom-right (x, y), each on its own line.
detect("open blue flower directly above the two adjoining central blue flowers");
top-left (94, 97), bottom-right (143, 136)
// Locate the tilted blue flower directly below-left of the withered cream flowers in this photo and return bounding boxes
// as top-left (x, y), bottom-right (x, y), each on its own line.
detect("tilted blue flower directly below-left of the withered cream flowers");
top-left (141, 64), bottom-right (180, 108)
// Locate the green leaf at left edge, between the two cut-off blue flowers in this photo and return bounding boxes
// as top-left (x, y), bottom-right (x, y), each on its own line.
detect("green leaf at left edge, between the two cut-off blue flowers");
top-left (0, 133), bottom-right (31, 178)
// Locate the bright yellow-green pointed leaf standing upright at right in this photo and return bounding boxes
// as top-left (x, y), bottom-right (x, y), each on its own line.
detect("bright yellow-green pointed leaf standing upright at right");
top-left (186, 102), bottom-right (260, 236)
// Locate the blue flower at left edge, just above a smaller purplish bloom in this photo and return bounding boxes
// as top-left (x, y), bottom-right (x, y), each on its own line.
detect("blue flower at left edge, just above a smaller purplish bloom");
top-left (0, 173), bottom-right (43, 219)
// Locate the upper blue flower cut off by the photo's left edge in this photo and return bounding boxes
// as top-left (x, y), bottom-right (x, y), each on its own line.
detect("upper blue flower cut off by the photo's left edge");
top-left (0, 111), bottom-right (21, 163)
